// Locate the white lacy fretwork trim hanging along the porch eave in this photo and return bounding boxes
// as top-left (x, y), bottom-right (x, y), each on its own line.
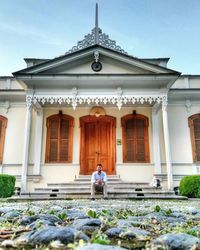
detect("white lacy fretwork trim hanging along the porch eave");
top-left (26, 93), bottom-right (167, 109)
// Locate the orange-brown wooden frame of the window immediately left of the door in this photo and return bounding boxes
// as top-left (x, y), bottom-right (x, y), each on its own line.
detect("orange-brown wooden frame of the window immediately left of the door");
top-left (45, 113), bottom-right (74, 164)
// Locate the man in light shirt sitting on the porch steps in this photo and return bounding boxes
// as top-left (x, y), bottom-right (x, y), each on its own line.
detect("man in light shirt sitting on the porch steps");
top-left (91, 163), bottom-right (107, 200)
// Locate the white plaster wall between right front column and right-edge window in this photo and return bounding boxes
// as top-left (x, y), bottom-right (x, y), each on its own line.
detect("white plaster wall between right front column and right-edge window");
top-left (168, 104), bottom-right (200, 179)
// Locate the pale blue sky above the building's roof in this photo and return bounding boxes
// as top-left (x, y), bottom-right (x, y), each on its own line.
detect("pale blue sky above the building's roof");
top-left (0, 0), bottom-right (200, 76)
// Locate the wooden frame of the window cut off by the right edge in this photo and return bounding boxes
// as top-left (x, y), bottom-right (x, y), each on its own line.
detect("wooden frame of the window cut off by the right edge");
top-left (188, 113), bottom-right (200, 163)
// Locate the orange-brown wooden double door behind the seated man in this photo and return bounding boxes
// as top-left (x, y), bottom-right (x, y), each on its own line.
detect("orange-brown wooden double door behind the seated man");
top-left (80, 115), bottom-right (116, 175)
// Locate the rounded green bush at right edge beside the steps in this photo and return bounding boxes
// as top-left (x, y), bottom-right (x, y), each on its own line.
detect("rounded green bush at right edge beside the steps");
top-left (179, 175), bottom-right (200, 198)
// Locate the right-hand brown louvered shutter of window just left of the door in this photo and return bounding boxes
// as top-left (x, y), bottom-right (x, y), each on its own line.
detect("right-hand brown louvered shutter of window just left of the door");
top-left (60, 119), bottom-right (69, 162)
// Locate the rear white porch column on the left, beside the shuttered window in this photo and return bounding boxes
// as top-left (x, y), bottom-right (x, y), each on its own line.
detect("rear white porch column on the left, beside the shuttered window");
top-left (33, 108), bottom-right (43, 175)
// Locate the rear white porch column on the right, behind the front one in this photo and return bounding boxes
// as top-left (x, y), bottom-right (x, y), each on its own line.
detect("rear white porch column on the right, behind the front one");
top-left (152, 106), bottom-right (162, 174)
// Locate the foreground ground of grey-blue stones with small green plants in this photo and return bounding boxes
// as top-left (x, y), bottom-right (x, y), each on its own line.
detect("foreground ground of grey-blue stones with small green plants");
top-left (0, 200), bottom-right (200, 250)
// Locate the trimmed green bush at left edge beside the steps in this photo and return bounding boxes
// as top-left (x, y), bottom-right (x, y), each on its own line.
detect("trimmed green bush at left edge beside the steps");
top-left (0, 174), bottom-right (16, 198)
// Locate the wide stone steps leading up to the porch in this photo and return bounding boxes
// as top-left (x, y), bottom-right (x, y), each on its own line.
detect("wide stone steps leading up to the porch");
top-left (15, 175), bottom-right (185, 200)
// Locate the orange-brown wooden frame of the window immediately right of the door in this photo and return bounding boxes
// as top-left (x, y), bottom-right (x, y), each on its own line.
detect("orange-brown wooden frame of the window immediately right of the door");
top-left (121, 114), bottom-right (150, 163)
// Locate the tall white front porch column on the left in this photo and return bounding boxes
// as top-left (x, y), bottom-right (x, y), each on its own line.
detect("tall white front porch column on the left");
top-left (21, 104), bottom-right (32, 193)
